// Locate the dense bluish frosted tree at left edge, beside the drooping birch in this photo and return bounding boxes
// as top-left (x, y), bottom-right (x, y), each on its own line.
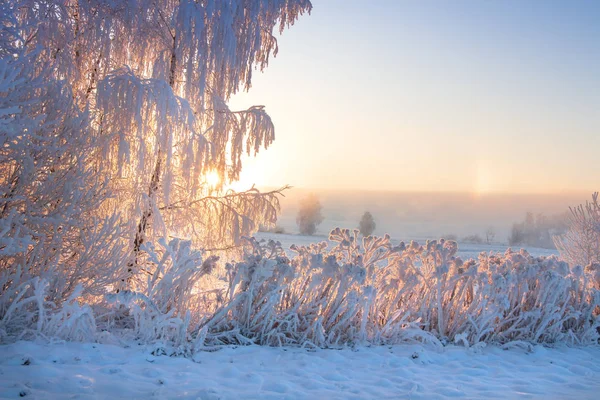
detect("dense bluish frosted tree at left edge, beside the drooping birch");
top-left (0, 3), bottom-right (122, 340)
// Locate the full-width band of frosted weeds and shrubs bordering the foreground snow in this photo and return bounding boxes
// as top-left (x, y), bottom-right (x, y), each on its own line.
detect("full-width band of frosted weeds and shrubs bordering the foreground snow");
top-left (0, 229), bottom-right (600, 354)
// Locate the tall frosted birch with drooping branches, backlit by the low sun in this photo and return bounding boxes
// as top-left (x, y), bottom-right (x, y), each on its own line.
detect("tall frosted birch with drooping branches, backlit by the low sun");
top-left (11, 0), bottom-right (311, 280)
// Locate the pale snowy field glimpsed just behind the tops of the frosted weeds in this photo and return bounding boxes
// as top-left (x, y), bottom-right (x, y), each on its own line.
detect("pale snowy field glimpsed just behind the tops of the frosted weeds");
top-left (255, 232), bottom-right (558, 260)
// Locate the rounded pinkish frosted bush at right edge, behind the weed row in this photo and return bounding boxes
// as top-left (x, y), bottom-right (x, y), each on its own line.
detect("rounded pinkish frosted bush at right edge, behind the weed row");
top-left (554, 192), bottom-right (600, 266)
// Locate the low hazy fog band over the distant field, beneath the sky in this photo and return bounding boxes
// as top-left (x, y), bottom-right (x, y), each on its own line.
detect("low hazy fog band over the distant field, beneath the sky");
top-left (278, 188), bottom-right (590, 243)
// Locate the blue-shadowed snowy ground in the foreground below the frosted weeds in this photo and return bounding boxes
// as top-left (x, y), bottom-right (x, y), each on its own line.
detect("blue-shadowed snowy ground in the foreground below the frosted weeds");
top-left (0, 342), bottom-right (600, 400)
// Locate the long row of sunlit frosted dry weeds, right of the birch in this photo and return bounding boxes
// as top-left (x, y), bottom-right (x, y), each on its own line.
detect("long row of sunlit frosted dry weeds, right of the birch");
top-left (196, 229), bottom-right (600, 348)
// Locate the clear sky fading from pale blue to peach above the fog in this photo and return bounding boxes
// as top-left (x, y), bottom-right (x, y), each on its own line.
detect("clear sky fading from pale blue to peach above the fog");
top-left (232, 0), bottom-right (600, 192)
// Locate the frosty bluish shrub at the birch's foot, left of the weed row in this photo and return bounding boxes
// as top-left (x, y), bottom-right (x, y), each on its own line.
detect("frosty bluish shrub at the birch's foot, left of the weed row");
top-left (98, 239), bottom-right (218, 346)
